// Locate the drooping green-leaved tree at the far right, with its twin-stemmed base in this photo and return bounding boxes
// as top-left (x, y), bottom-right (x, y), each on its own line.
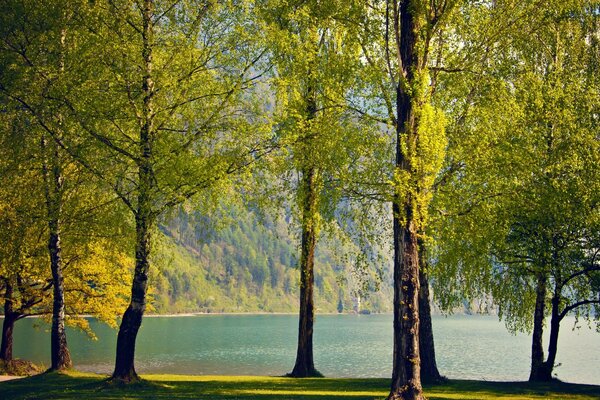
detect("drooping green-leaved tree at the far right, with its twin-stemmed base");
top-left (437, 2), bottom-right (598, 380)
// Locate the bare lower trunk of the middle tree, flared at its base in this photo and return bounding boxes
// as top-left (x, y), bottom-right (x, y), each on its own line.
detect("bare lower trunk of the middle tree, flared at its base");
top-left (289, 167), bottom-right (321, 378)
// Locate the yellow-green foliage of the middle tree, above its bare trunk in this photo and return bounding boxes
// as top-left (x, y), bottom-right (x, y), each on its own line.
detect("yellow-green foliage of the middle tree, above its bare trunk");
top-left (248, 1), bottom-right (386, 268)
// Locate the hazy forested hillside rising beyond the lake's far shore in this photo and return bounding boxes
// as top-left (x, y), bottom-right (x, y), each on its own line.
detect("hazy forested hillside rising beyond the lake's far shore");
top-left (153, 207), bottom-right (392, 313)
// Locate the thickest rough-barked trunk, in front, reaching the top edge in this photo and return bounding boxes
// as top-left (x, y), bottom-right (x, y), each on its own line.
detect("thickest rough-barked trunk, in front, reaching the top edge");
top-left (388, 0), bottom-right (425, 400)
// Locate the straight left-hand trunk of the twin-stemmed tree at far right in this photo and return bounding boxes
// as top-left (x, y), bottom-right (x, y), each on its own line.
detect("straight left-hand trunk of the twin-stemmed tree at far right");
top-left (529, 274), bottom-right (547, 382)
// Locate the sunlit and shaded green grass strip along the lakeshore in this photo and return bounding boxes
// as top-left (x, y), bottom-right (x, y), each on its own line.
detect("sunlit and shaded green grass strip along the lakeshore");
top-left (0, 372), bottom-right (600, 400)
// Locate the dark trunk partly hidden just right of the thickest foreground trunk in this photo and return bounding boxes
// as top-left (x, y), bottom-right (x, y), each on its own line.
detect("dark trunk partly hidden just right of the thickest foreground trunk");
top-left (419, 252), bottom-right (445, 383)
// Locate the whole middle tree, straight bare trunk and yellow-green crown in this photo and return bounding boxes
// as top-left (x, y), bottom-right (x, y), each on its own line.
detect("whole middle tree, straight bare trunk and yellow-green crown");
top-left (261, 1), bottom-right (370, 377)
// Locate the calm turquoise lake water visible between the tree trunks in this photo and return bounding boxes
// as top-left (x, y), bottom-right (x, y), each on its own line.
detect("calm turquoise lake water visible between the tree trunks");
top-left (9, 315), bottom-right (600, 384)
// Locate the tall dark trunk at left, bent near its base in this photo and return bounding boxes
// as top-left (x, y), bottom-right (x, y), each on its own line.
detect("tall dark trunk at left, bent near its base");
top-left (112, 0), bottom-right (156, 383)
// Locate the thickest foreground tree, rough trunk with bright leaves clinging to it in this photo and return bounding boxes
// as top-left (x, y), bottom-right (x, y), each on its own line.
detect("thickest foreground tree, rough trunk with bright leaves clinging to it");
top-left (356, 1), bottom-right (455, 399)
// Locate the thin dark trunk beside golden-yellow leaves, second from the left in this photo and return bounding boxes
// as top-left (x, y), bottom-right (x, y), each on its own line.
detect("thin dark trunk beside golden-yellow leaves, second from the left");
top-left (41, 137), bottom-right (73, 371)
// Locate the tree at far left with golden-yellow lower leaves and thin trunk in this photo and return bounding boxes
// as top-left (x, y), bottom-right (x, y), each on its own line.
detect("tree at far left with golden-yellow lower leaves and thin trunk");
top-left (0, 1), bottom-right (135, 370)
